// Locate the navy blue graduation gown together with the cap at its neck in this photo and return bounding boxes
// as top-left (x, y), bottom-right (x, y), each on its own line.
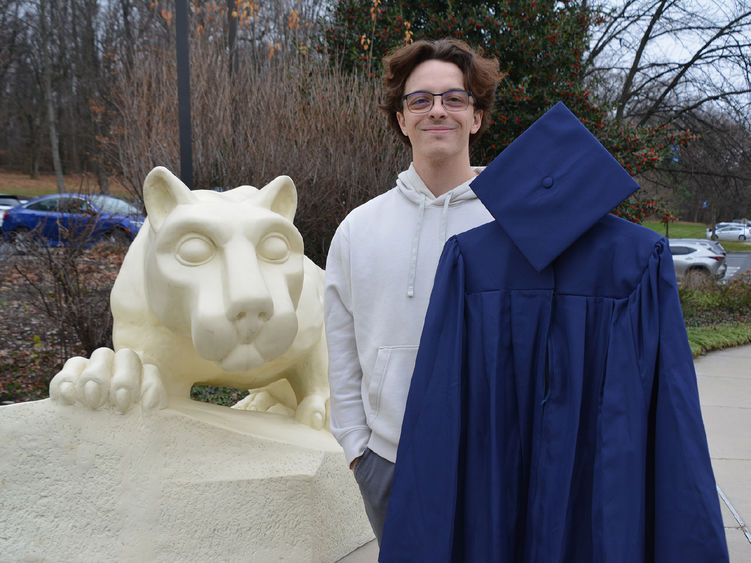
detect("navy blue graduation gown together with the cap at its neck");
top-left (380, 104), bottom-right (728, 563)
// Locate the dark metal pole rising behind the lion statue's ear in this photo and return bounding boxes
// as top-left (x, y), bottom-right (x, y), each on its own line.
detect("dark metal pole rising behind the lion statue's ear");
top-left (175, 0), bottom-right (193, 190)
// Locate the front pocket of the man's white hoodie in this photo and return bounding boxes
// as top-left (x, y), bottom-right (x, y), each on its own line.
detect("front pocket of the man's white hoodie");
top-left (368, 346), bottom-right (417, 427)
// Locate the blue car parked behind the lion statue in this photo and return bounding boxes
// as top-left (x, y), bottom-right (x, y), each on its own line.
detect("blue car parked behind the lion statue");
top-left (2, 194), bottom-right (144, 250)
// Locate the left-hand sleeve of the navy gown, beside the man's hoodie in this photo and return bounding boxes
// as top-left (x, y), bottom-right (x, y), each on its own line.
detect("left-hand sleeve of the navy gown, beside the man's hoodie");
top-left (379, 238), bottom-right (465, 563)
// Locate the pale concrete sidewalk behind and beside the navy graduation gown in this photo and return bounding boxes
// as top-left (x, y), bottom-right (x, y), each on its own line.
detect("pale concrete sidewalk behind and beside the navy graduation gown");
top-left (341, 346), bottom-right (751, 563)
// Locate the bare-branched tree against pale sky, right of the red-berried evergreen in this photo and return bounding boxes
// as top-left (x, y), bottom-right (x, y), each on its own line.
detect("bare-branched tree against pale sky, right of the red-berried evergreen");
top-left (585, 0), bottom-right (751, 224)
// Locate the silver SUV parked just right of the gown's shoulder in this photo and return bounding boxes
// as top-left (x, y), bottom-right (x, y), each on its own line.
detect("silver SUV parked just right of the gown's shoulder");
top-left (669, 238), bottom-right (727, 285)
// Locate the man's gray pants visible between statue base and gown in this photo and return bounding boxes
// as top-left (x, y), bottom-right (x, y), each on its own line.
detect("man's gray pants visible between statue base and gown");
top-left (354, 448), bottom-right (394, 546)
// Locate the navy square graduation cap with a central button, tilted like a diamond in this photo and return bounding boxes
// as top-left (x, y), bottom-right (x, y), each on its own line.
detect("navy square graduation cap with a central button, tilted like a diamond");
top-left (471, 102), bottom-right (639, 272)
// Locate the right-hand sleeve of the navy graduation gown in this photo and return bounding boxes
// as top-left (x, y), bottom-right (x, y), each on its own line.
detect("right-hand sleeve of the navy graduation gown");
top-left (650, 240), bottom-right (728, 562)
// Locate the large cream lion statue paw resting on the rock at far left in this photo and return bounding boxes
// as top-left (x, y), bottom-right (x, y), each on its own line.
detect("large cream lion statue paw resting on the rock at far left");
top-left (50, 348), bottom-right (167, 413)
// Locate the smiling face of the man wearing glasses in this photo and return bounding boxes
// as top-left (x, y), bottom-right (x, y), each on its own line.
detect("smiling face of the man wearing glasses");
top-left (396, 59), bottom-right (482, 164)
